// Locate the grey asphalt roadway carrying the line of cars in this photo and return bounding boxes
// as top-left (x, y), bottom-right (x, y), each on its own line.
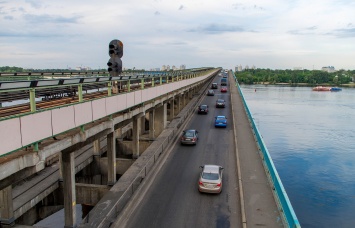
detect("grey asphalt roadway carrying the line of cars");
top-left (124, 77), bottom-right (242, 228)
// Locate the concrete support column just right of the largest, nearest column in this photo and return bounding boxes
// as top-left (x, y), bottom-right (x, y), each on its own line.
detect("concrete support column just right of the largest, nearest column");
top-left (107, 131), bottom-right (116, 186)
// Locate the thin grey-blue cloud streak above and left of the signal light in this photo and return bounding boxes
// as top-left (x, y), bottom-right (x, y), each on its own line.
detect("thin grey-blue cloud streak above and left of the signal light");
top-left (24, 14), bottom-right (81, 24)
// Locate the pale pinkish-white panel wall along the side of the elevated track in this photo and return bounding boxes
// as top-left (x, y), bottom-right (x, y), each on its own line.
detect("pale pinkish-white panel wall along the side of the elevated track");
top-left (0, 72), bottom-right (215, 156)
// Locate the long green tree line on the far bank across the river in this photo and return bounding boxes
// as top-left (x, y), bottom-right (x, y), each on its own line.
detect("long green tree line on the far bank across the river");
top-left (235, 69), bottom-right (355, 86)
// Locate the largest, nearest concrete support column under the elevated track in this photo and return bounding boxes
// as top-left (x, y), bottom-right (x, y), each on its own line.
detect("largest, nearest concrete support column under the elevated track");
top-left (61, 151), bottom-right (76, 228)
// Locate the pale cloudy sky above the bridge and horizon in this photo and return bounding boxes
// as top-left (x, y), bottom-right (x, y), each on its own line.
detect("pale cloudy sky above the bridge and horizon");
top-left (0, 0), bottom-right (355, 70)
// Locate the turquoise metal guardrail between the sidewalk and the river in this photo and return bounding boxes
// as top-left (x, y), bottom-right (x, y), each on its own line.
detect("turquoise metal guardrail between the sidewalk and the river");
top-left (234, 75), bottom-right (301, 228)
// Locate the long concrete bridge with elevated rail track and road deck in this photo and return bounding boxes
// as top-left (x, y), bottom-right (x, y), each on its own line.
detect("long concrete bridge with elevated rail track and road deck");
top-left (0, 68), bottom-right (300, 227)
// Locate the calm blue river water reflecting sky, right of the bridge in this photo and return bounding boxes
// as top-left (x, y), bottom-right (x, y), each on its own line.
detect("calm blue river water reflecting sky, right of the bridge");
top-left (241, 85), bottom-right (355, 228)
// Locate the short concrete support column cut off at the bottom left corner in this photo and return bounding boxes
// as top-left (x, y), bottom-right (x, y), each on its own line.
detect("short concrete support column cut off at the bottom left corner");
top-left (0, 185), bottom-right (15, 227)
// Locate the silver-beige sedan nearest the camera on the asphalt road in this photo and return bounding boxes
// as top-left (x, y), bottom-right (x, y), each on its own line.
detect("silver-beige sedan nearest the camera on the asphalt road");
top-left (198, 165), bottom-right (223, 193)
